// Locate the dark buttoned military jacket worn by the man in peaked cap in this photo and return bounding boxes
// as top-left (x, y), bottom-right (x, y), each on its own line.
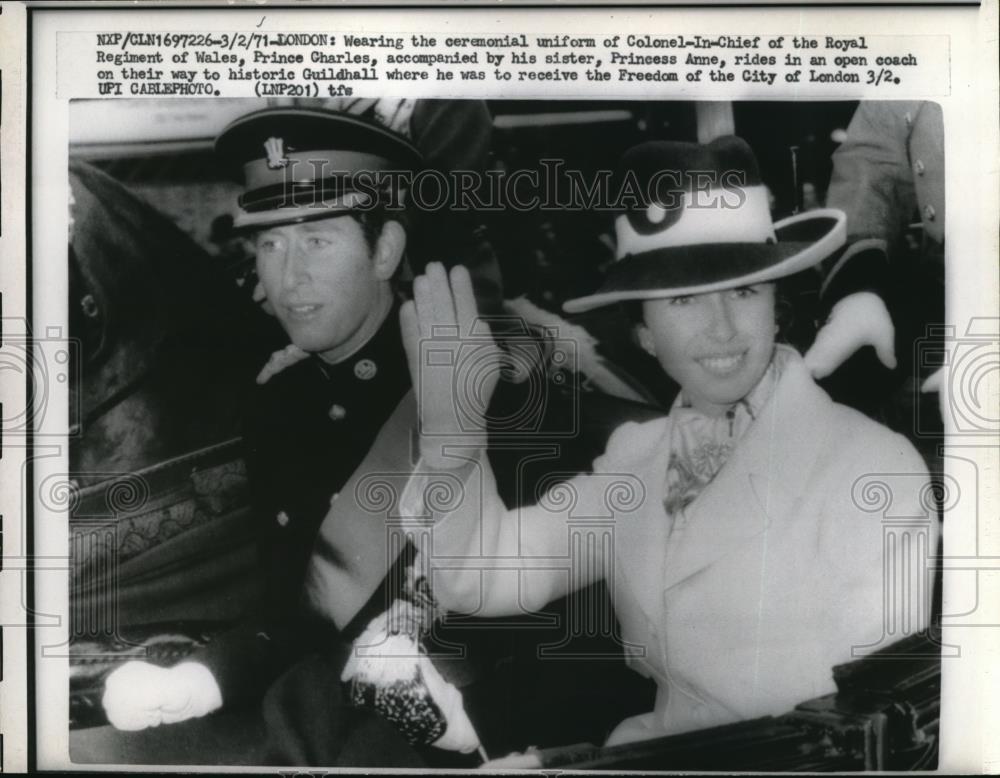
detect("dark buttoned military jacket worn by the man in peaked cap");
top-left (193, 310), bottom-right (410, 705)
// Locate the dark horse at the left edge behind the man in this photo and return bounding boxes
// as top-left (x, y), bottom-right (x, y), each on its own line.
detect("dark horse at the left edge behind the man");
top-left (69, 161), bottom-right (279, 485)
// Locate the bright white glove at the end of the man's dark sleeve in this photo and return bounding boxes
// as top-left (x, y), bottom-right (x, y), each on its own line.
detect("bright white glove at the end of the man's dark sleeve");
top-left (101, 662), bottom-right (222, 731)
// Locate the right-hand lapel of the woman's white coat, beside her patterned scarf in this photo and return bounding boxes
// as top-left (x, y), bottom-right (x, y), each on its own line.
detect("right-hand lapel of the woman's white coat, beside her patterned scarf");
top-left (663, 354), bottom-right (829, 588)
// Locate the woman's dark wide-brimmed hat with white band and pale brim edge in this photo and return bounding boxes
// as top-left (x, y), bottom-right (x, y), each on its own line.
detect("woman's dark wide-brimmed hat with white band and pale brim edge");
top-left (563, 136), bottom-right (846, 313)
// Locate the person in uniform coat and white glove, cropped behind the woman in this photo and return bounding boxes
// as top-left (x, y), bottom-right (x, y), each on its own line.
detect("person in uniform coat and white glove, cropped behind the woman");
top-left (806, 101), bottom-right (945, 394)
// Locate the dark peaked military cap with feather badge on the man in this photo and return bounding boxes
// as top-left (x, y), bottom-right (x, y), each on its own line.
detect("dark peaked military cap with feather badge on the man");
top-left (215, 100), bottom-right (424, 230)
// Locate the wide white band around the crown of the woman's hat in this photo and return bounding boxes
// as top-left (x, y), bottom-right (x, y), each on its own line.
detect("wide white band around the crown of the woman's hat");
top-left (615, 184), bottom-right (775, 260)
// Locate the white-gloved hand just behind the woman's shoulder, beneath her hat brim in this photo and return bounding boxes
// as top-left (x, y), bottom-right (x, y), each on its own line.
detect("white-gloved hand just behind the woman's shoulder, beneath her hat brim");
top-left (805, 292), bottom-right (896, 379)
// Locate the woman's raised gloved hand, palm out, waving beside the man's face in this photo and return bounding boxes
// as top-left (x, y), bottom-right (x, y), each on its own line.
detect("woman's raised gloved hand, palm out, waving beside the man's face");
top-left (400, 262), bottom-right (502, 469)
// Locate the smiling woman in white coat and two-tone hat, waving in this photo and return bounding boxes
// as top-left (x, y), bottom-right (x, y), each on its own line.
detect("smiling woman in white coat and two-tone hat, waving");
top-left (402, 138), bottom-right (937, 743)
